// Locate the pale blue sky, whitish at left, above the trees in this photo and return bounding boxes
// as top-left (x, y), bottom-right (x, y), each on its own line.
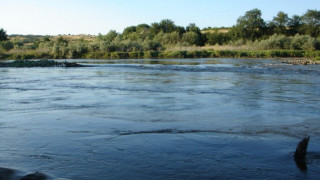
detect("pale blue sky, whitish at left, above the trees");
top-left (0, 0), bottom-right (320, 35)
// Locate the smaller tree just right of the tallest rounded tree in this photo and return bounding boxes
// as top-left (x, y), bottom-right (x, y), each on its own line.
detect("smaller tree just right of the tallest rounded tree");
top-left (271, 11), bottom-right (289, 34)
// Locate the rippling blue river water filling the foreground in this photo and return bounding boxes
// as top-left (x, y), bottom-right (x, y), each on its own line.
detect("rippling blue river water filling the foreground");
top-left (0, 59), bottom-right (320, 180)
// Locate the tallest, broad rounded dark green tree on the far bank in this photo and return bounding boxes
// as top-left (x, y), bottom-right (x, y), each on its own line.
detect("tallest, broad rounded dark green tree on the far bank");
top-left (231, 9), bottom-right (266, 41)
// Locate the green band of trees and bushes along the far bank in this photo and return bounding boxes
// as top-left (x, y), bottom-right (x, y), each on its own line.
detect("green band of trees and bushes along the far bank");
top-left (0, 9), bottom-right (320, 59)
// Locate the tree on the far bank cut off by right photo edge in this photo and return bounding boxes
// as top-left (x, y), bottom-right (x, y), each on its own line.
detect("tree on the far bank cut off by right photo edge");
top-left (302, 10), bottom-right (320, 37)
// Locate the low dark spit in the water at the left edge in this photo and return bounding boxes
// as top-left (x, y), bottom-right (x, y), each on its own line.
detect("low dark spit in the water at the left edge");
top-left (0, 60), bottom-right (83, 67)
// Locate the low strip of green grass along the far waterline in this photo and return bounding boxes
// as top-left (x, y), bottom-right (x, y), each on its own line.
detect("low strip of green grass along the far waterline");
top-left (0, 50), bottom-right (320, 60)
